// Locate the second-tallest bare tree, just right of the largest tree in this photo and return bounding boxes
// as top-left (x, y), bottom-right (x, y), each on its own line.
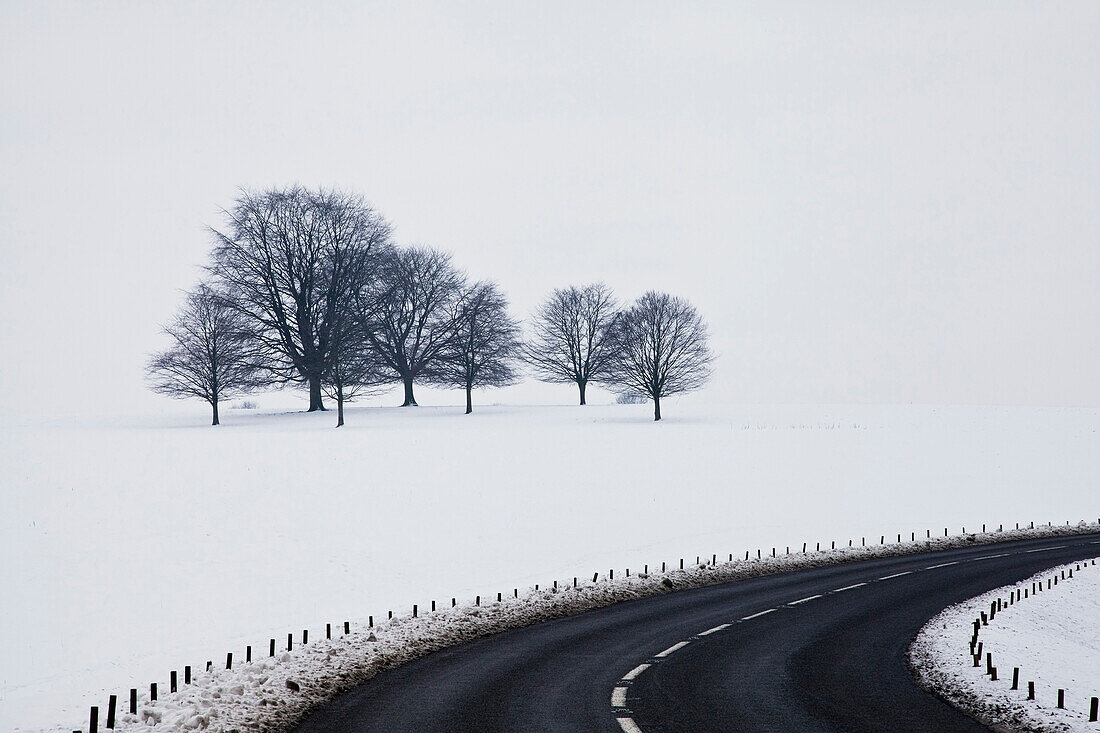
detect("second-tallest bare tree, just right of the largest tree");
top-left (365, 247), bottom-right (465, 407)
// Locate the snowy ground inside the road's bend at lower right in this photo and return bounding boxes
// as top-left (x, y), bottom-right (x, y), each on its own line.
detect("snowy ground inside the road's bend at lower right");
top-left (910, 559), bottom-right (1100, 732)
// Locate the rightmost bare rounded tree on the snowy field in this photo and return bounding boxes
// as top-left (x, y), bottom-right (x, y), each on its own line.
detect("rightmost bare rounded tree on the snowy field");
top-left (606, 291), bottom-right (714, 420)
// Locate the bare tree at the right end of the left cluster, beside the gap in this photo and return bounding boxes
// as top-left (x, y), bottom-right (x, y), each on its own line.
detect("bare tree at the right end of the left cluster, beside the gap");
top-left (433, 282), bottom-right (520, 415)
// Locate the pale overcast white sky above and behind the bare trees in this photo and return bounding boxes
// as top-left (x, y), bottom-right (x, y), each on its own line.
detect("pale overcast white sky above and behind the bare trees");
top-left (0, 0), bottom-right (1100, 414)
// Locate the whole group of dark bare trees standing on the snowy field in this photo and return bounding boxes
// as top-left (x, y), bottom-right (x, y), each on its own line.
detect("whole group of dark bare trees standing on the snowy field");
top-left (146, 186), bottom-right (713, 426)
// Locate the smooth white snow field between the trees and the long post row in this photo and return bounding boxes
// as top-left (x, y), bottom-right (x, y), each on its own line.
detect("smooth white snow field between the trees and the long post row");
top-left (0, 395), bottom-right (1100, 731)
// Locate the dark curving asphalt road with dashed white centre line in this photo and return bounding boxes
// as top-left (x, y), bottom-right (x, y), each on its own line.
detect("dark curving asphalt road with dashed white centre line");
top-left (297, 534), bottom-right (1100, 733)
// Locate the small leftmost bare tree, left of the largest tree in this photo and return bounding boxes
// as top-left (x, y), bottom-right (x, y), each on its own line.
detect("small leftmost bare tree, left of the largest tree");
top-left (145, 285), bottom-right (254, 425)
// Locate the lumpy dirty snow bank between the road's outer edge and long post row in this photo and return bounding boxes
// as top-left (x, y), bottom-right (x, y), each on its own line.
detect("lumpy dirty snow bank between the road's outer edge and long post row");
top-left (90, 522), bottom-right (1100, 731)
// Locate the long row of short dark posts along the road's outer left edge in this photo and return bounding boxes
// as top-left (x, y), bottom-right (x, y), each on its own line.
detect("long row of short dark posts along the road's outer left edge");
top-left (74, 517), bottom-right (1100, 733)
